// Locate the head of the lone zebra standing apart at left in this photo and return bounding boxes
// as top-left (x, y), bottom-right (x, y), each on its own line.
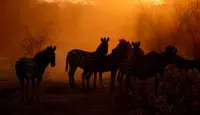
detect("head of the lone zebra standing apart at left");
top-left (45, 46), bottom-right (56, 67)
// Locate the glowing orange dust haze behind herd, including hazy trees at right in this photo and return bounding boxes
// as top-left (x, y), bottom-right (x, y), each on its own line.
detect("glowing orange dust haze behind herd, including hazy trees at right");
top-left (0, 0), bottom-right (200, 81)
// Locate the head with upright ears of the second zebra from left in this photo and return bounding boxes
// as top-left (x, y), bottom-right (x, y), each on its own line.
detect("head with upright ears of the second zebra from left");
top-left (96, 37), bottom-right (110, 55)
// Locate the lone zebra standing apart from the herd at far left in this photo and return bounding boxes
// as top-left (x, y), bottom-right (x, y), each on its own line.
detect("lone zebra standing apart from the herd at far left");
top-left (15, 46), bottom-right (56, 101)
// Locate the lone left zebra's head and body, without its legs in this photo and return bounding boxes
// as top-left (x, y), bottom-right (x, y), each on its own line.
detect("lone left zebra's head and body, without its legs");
top-left (15, 46), bottom-right (56, 78)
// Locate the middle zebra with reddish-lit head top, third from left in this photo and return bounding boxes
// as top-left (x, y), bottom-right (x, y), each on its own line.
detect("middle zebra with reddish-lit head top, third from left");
top-left (82, 39), bottom-right (130, 91)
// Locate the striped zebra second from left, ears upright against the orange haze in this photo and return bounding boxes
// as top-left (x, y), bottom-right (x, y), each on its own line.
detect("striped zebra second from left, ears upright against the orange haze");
top-left (65, 37), bottom-right (110, 87)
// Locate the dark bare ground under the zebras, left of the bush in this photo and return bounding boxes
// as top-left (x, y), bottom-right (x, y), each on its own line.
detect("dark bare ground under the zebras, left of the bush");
top-left (0, 81), bottom-right (141, 115)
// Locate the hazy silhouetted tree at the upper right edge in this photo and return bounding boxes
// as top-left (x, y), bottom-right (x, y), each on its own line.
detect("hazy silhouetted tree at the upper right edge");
top-left (177, 1), bottom-right (200, 59)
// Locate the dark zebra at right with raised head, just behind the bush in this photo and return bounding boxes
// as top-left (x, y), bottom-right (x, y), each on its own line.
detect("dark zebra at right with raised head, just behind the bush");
top-left (118, 45), bottom-right (177, 95)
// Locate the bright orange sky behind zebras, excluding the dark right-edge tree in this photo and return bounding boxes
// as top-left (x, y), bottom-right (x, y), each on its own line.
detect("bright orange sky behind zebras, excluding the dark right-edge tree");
top-left (0, 0), bottom-right (198, 80)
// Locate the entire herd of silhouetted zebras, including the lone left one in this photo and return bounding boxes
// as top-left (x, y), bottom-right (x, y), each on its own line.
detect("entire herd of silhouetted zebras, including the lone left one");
top-left (15, 38), bottom-right (200, 100)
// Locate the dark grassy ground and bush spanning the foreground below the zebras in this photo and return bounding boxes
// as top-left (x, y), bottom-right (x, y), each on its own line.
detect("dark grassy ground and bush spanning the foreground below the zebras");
top-left (0, 65), bottom-right (200, 115)
